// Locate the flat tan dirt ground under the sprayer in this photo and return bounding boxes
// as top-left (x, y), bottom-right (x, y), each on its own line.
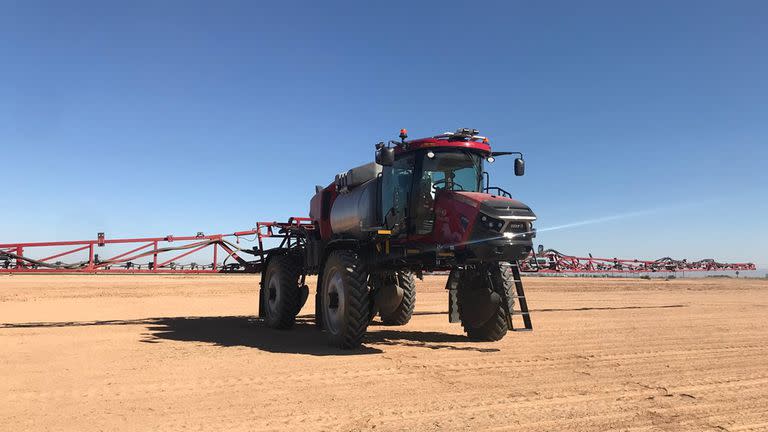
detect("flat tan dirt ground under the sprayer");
top-left (0, 275), bottom-right (768, 431)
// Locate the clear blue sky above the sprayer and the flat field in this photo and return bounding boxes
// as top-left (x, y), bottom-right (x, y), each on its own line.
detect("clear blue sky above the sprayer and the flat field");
top-left (0, 1), bottom-right (768, 266)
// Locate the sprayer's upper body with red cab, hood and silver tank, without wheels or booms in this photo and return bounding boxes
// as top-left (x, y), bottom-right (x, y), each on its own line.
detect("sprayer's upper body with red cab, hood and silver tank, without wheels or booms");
top-left (310, 129), bottom-right (536, 268)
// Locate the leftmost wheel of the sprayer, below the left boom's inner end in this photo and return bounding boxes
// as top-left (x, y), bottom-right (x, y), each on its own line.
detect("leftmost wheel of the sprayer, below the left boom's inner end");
top-left (262, 255), bottom-right (302, 329)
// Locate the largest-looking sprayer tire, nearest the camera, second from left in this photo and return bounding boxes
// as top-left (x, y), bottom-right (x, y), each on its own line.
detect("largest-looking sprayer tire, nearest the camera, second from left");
top-left (319, 250), bottom-right (371, 349)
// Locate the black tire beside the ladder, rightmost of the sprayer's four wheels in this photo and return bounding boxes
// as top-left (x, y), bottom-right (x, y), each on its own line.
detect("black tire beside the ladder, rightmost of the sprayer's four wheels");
top-left (457, 263), bottom-right (514, 341)
